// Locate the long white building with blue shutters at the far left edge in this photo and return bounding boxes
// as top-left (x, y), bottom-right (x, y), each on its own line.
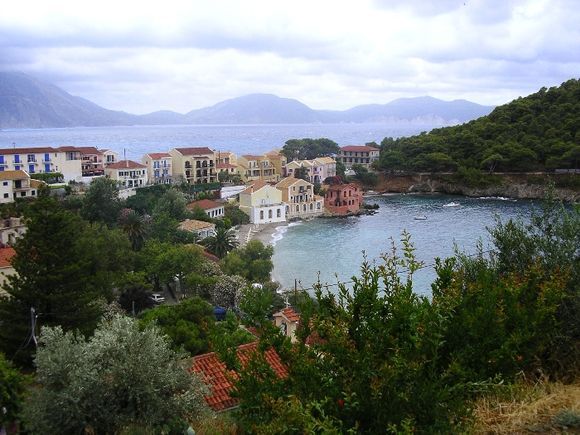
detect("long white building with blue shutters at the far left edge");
top-left (0, 146), bottom-right (82, 182)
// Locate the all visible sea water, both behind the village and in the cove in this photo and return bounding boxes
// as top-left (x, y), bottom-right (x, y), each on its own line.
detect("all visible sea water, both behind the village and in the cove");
top-left (0, 123), bottom-right (536, 295)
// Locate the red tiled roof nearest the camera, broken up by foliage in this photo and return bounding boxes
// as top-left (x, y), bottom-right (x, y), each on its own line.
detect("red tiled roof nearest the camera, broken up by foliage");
top-left (189, 342), bottom-right (288, 411)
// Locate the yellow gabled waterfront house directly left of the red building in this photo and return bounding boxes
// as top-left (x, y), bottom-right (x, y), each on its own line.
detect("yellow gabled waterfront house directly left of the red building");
top-left (276, 177), bottom-right (324, 219)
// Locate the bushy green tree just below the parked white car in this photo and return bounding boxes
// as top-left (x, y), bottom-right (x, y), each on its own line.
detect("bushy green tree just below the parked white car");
top-left (139, 297), bottom-right (214, 355)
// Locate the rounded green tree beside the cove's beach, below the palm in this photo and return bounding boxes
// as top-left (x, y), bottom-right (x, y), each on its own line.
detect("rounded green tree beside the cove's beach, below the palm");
top-left (221, 240), bottom-right (274, 282)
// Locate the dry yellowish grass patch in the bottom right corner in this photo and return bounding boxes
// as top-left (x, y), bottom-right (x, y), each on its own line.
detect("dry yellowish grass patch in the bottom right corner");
top-left (474, 380), bottom-right (580, 434)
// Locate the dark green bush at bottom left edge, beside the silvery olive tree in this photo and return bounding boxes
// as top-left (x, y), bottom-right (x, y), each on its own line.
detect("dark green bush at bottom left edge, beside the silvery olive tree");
top-left (0, 353), bottom-right (27, 428)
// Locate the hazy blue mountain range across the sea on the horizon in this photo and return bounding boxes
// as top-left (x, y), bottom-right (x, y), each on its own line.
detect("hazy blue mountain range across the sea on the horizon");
top-left (0, 72), bottom-right (493, 128)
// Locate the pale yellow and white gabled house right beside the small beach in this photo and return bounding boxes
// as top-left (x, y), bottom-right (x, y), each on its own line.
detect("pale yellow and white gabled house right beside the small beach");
top-left (240, 181), bottom-right (286, 224)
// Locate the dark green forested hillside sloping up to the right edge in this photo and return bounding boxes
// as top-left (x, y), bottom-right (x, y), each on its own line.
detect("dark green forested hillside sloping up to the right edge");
top-left (379, 79), bottom-right (580, 172)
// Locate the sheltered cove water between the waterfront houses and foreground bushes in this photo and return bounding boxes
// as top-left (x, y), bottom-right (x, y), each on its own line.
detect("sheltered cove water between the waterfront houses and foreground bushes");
top-left (273, 195), bottom-right (534, 295)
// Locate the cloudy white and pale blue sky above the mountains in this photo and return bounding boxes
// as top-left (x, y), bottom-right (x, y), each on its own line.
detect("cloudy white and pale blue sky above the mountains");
top-left (0, 0), bottom-right (580, 114)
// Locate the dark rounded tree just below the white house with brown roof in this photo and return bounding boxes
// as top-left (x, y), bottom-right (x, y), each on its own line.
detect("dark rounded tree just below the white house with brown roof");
top-left (81, 177), bottom-right (121, 227)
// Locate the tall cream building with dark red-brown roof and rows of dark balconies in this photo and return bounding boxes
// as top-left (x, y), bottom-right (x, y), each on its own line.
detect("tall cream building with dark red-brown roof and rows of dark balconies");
top-left (169, 147), bottom-right (218, 184)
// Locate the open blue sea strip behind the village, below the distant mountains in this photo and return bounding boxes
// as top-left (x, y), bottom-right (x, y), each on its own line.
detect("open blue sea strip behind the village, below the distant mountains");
top-left (0, 123), bottom-right (440, 161)
